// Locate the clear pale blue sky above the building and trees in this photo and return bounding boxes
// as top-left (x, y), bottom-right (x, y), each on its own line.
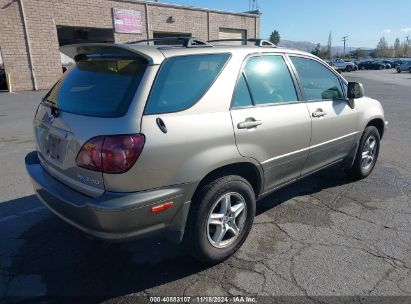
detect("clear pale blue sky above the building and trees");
top-left (160, 0), bottom-right (411, 48)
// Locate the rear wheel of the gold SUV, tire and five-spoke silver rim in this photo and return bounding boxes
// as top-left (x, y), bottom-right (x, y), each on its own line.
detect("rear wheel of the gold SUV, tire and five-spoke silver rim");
top-left (184, 175), bottom-right (256, 264)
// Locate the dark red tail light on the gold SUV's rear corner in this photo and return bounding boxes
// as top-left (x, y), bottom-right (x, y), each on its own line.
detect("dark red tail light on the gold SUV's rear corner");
top-left (76, 134), bottom-right (145, 173)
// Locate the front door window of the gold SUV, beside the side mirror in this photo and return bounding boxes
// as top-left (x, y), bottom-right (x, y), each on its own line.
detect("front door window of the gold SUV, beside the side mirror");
top-left (290, 56), bottom-right (343, 100)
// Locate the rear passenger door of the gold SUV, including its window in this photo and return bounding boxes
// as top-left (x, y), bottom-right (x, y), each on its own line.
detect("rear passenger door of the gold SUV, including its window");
top-left (231, 54), bottom-right (311, 190)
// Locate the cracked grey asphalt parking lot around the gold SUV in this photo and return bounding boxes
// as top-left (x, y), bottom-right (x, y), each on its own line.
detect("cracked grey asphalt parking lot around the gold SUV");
top-left (0, 70), bottom-right (411, 303)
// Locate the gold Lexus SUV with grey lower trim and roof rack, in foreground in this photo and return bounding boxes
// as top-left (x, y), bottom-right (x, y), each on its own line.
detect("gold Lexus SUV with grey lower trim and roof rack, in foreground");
top-left (25, 38), bottom-right (385, 263)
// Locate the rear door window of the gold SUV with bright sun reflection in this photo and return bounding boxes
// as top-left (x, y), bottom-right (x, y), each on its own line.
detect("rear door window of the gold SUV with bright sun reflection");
top-left (244, 55), bottom-right (298, 105)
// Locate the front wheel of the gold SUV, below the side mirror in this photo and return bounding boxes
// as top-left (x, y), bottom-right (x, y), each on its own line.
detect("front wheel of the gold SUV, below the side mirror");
top-left (346, 126), bottom-right (380, 180)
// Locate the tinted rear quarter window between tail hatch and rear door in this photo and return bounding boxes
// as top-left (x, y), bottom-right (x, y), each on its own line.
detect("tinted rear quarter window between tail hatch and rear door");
top-left (145, 54), bottom-right (230, 114)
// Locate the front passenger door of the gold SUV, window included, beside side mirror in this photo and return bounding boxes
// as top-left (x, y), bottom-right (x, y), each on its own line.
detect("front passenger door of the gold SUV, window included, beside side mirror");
top-left (290, 56), bottom-right (357, 174)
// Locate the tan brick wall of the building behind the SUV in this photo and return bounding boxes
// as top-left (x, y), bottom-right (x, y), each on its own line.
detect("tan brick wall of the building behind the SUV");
top-left (0, 0), bottom-right (259, 91)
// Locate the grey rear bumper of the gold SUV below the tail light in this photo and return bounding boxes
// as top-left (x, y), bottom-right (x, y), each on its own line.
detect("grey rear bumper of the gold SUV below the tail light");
top-left (25, 152), bottom-right (195, 242)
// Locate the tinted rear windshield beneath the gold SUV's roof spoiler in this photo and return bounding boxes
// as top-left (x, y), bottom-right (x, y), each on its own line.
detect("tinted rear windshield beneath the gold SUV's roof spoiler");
top-left (46, 55), bottom-right (147, 117)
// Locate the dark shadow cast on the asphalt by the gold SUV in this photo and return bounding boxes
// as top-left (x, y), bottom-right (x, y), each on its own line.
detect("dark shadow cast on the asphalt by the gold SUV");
top-left (0, 168), bottom-right (347, 303)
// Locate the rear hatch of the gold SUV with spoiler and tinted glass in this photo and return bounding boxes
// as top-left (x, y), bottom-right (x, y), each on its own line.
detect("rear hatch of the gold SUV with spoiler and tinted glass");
top-left (34, 45), bottom-right (159, 197)
